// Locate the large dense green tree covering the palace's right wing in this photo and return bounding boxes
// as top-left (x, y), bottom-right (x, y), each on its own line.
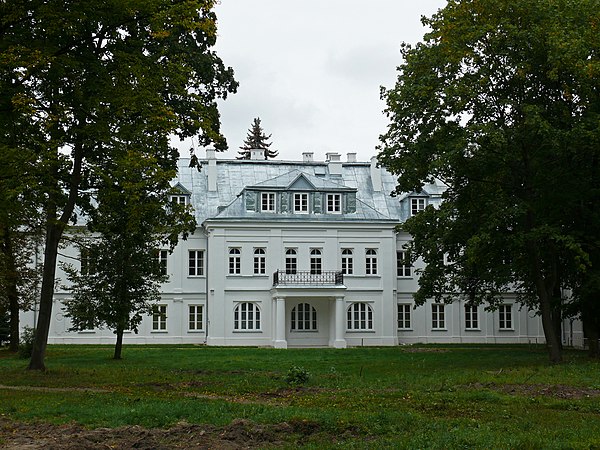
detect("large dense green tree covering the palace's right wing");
top-left (379, 0), bottom-right (600, 362)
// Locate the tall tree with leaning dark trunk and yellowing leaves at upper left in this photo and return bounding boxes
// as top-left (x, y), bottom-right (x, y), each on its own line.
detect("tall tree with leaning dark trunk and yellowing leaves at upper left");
top-left (0, 0), bottom-right (236, 369)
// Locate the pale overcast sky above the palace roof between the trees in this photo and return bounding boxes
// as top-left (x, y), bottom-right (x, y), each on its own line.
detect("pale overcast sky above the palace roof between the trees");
top-left (195, 0), bottom-right (446, 161)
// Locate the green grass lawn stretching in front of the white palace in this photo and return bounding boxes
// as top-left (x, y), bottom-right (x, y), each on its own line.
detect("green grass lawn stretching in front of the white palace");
top-left (0, 345), bottom-right (600, 449)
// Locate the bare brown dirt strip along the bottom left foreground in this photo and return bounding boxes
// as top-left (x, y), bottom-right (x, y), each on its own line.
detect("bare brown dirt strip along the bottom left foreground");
top-left (0, 418), bottom-right (338, 450)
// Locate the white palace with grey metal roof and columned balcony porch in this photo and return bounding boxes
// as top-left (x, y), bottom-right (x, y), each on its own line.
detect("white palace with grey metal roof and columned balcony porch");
top-left (22, 150), bottom-right (582, 348)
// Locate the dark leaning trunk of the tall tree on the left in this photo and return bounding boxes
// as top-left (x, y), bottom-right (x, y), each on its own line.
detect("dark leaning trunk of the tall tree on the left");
top-left (28, 224), bottom-right (64, 370)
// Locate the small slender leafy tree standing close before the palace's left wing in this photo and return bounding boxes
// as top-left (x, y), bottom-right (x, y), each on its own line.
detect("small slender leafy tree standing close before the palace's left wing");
top-left (65, 149), bottom-right (196, 359)
